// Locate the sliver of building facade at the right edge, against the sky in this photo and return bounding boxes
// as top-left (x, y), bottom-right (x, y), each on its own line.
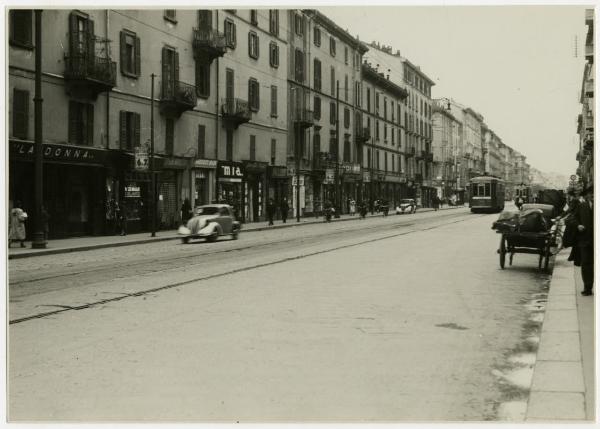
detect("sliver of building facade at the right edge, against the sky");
top-left (576, 9), bottom-right (596, 187)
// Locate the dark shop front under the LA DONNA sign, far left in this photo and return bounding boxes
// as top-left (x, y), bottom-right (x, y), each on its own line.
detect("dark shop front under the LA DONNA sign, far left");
top-left (8, 141), bottom-right (110, 239)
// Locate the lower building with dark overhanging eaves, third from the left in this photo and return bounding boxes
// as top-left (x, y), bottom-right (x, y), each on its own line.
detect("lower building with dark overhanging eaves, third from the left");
top-left (357, 63), bottom-right (408, 207)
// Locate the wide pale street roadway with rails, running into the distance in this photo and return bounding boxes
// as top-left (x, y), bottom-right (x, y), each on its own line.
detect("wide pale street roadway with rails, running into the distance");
top-left (8, 209), bottom-right (548, 422)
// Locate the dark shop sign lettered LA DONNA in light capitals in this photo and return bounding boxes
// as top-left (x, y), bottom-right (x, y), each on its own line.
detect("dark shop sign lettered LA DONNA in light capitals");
top-left (10, 141), bottom-right (107, 164)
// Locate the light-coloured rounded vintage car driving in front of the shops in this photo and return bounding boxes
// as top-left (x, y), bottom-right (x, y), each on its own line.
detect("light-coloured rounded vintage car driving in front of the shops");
top-left (177, 204), bottom-right (241, 243)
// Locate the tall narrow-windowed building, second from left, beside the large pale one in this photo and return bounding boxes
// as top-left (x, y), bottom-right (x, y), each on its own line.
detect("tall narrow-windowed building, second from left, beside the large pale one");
top-left (287, 9), bottom-right (368, 214)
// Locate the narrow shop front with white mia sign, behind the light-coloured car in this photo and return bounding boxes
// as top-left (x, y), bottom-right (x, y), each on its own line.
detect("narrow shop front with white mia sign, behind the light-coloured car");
top-left (217, 161), bottom-right (246, 222)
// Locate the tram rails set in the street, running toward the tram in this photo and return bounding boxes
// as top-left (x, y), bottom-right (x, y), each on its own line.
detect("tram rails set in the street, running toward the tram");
top-left (9, 213), bottom-right (485, 325)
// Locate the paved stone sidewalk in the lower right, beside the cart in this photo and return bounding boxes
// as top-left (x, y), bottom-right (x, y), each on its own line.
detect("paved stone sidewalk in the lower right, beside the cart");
top-left (525, 250), bottom-right (596, 422)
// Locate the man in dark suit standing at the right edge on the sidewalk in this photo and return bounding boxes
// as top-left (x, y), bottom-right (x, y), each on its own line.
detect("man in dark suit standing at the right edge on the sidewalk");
top-left (575, 186), bottom-right (594, 296)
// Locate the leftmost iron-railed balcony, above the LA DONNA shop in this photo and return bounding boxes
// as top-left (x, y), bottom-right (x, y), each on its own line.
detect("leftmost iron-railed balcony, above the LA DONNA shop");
top-left (65, 54), bottom-right (117, 100)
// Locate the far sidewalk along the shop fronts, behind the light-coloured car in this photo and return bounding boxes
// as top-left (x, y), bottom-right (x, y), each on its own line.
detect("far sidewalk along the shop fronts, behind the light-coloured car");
top-left (8, 206), bottom-right (464, 259)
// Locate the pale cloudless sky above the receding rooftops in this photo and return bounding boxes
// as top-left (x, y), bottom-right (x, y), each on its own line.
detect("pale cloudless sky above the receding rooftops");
top-left (317, 5), bottom-right (593, 175)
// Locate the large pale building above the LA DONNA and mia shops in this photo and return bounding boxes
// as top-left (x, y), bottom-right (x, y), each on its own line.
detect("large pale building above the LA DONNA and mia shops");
top-left (9, 9), bottom-right (288, 237)
